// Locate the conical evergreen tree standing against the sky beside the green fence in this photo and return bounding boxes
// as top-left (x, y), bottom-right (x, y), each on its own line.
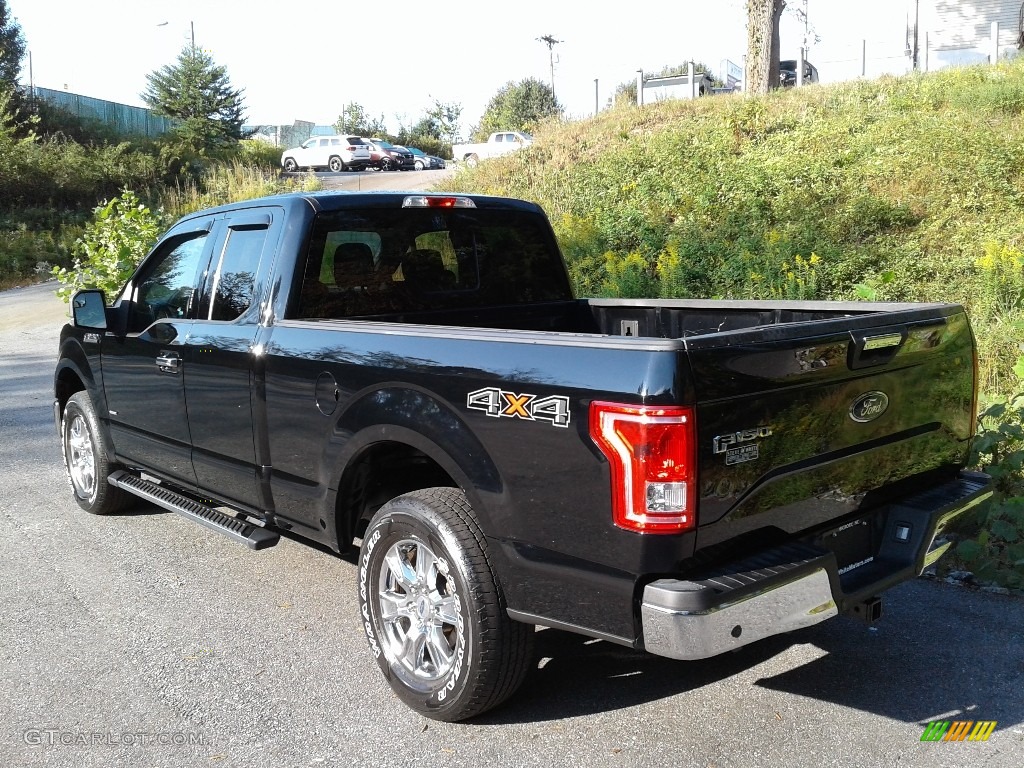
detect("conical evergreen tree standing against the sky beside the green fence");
top-left (141, 45), bottom-right (245, 157)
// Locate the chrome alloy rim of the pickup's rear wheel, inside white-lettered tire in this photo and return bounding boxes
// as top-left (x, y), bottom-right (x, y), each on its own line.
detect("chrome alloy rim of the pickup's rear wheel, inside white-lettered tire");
top-left (379, 539), bottom-right (465, 688)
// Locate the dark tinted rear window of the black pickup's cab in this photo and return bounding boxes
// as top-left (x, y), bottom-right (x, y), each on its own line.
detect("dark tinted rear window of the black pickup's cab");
top-left (289, 208), bottom-right (572, 318)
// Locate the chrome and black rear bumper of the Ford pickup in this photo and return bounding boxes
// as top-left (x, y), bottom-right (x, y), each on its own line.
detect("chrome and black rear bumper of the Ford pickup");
top-left (640, 472), bottom-right (992, 659)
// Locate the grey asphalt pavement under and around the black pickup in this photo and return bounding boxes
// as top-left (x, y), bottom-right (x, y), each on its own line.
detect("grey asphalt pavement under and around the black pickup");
top-left (0, 284), bottom-right (1024, 768)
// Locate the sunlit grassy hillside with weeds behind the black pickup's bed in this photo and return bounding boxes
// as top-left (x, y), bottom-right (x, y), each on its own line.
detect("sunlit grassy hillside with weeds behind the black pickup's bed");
top-left (450, 61), bottom-right (1024, 399)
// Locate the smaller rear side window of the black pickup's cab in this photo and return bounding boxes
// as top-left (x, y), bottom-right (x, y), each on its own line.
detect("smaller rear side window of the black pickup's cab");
top-left (200, 226), bottom-right (268, 321)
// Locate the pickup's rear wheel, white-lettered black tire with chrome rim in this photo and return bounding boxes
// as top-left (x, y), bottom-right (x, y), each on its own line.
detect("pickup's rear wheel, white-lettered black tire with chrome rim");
top-left (358, 487), bottom-right (534, 722)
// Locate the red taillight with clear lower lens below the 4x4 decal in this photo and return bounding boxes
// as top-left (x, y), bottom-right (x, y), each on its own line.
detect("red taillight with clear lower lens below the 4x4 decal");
top-left (590, 401), bottom-right (697, 534)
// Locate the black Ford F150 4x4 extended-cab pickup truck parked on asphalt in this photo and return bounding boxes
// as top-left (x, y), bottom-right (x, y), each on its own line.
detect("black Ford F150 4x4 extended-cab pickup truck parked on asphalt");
top-left (54, 193), bottom-right (990, 720)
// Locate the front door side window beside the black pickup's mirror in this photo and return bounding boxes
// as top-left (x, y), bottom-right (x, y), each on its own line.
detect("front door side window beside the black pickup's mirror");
top-left (128, 231), bottom-right (207, 333)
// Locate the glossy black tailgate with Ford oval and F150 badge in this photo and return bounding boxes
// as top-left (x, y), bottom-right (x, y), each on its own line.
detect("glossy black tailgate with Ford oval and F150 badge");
top-left (687, 310), bottom-right (975, 549)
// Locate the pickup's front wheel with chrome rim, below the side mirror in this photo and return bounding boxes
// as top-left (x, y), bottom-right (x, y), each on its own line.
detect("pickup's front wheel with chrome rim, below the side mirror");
top-left (60, 392), bottom-right (135, 515)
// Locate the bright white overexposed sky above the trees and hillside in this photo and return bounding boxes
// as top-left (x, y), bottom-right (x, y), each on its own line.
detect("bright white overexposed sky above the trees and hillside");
top-left (7, 0), bottom-right (912, 135)
